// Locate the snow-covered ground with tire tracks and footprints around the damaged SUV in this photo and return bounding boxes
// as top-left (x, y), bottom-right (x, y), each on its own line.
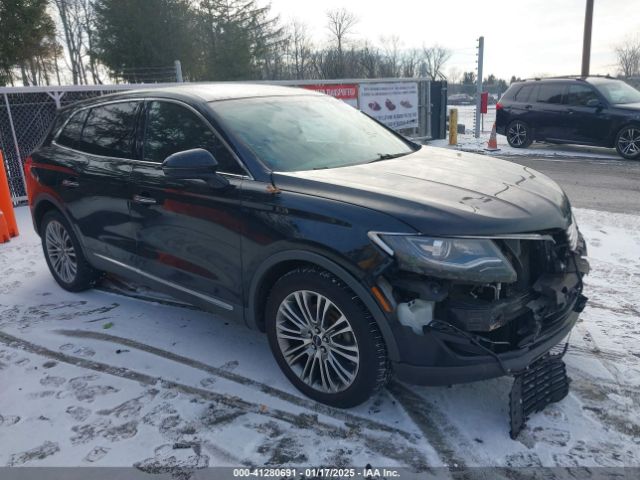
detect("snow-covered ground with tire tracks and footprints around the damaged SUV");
top-left (0, 207), bottom-right (640, 472)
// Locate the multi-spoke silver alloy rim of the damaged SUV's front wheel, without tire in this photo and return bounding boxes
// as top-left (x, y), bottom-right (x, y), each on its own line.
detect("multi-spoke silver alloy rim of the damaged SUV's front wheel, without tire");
top-left (276, 290), bottom-right (360, 393)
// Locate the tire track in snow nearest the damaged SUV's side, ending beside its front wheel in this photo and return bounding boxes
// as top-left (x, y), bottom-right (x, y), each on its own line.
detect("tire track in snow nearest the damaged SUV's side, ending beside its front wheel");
top-left (55, 330), bottom-right (411, 439)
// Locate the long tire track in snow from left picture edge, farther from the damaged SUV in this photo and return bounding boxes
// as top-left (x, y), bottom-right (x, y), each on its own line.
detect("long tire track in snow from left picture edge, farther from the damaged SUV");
top-left (0, 331), bottom-right (428, 471)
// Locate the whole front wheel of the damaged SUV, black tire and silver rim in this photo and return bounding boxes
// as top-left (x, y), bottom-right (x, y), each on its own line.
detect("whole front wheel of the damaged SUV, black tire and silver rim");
top-left (265, 268), bottom-right (389, 408)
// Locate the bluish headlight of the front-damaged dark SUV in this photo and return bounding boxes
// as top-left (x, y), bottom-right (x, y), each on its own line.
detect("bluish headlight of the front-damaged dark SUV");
top-left (369, 232), bottom-right (517, 283)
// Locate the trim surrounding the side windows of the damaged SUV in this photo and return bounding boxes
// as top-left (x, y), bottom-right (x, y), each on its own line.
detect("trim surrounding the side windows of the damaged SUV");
top-left (51, 97), bottom-right (255, 180)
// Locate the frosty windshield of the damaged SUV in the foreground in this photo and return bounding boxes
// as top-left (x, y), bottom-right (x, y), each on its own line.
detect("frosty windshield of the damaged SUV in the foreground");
top-left (211, 95), bottom-right (413, 172)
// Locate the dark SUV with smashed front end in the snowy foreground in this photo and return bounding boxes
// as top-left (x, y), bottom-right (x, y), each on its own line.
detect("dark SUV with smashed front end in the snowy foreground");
top-left (25, 84), bottom-right (587, 407)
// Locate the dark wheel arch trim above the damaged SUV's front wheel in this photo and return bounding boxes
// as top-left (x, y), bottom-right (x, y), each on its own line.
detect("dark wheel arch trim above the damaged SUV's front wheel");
top-left (245, 250), bottom-right (400, 361)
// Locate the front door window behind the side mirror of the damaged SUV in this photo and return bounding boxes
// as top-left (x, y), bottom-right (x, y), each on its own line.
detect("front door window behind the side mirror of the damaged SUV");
top-left (144, 102), bottom-right (244, 175)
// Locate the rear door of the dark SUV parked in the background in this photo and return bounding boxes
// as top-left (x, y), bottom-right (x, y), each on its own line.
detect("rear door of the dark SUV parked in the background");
top-left (533, 82), bottom-right (566, 140)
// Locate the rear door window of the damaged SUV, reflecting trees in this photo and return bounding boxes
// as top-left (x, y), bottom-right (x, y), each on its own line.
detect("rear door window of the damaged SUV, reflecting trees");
top-left (76, 102), bottom-right (139, 158)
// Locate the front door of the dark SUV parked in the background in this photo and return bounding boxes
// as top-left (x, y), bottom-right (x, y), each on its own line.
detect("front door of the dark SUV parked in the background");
top-left (565, 83), bottom-right (611, 145)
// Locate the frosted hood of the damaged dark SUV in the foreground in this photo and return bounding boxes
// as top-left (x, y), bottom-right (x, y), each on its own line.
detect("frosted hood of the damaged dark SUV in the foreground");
top-left (273, 147), bottom-right (571, 235)
